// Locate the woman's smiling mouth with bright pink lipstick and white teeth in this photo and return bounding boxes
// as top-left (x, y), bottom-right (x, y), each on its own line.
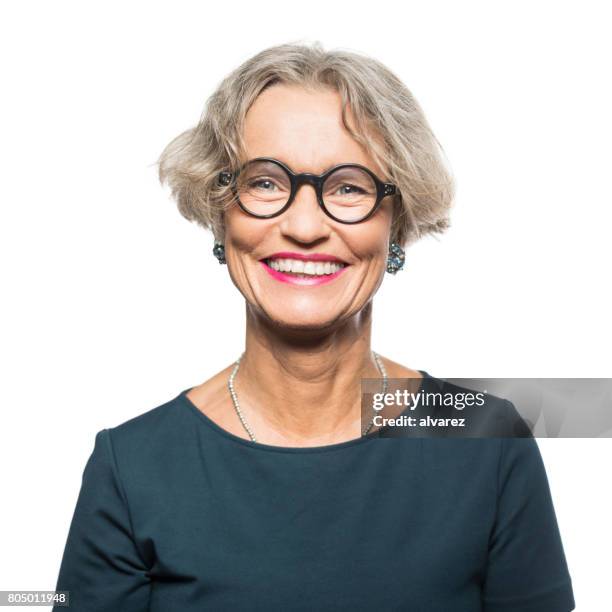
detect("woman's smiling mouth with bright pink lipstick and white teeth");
top-left (261, 253), bottom-right (347, 285)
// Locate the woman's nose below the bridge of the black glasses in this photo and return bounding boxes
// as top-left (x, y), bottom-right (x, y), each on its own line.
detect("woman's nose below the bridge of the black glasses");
top-left (280, 183), bottom-right (331, 244)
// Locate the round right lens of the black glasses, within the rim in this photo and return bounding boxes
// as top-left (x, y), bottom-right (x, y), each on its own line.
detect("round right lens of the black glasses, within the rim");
top-left (323, 166), bottom-right (377, 221)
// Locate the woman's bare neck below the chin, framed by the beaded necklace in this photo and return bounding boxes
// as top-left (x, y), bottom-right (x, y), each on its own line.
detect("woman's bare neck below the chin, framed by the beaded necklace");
top-left (234, 303), bottom-right (380, 446)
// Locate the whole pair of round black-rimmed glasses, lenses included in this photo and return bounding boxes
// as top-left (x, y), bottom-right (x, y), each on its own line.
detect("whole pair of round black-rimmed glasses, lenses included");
top-left (218, 157), bottom-right (396, 223)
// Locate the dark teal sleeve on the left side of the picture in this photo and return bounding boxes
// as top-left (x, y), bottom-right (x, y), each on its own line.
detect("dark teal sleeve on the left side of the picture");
top-left (52, 429), bottom-right (150, 612)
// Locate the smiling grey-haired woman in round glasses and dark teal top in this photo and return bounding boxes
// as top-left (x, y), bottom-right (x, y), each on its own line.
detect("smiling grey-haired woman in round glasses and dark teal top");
top-left (52, 44), bottom-right (574, 612)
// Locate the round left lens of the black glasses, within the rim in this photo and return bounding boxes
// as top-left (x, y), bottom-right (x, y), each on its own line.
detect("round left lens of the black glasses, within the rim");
top-left (237, 160), bottom-right (291, 216)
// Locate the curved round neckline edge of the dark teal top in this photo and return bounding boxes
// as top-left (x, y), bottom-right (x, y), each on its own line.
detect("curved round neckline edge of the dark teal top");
top-left (175, 370), bottom-right (433, 453)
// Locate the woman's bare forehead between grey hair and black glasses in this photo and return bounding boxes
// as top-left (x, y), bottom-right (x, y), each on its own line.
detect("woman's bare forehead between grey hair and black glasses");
top-left (244, 84), bottom-right (381, 173)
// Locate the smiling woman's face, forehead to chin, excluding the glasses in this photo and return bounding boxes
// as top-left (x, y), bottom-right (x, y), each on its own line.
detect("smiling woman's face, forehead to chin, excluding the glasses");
top-left (224, 84), bottom-right (392, 330)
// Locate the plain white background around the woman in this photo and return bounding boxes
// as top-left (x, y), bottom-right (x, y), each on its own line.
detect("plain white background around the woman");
top-left (0, 0), bottom-right (612, 612)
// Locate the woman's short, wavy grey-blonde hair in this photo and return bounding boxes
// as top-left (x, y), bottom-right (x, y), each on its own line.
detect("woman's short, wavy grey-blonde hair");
top-left (158, 42), bottom-right (454, 245)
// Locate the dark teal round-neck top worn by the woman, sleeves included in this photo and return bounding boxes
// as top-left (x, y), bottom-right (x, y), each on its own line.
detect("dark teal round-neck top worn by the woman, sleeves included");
top-left (54, 373), bottom-right (574, 612)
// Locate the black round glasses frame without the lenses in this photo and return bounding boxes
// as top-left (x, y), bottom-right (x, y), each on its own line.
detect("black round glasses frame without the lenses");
top-left (218, 157), bottom-right (397, 225)
